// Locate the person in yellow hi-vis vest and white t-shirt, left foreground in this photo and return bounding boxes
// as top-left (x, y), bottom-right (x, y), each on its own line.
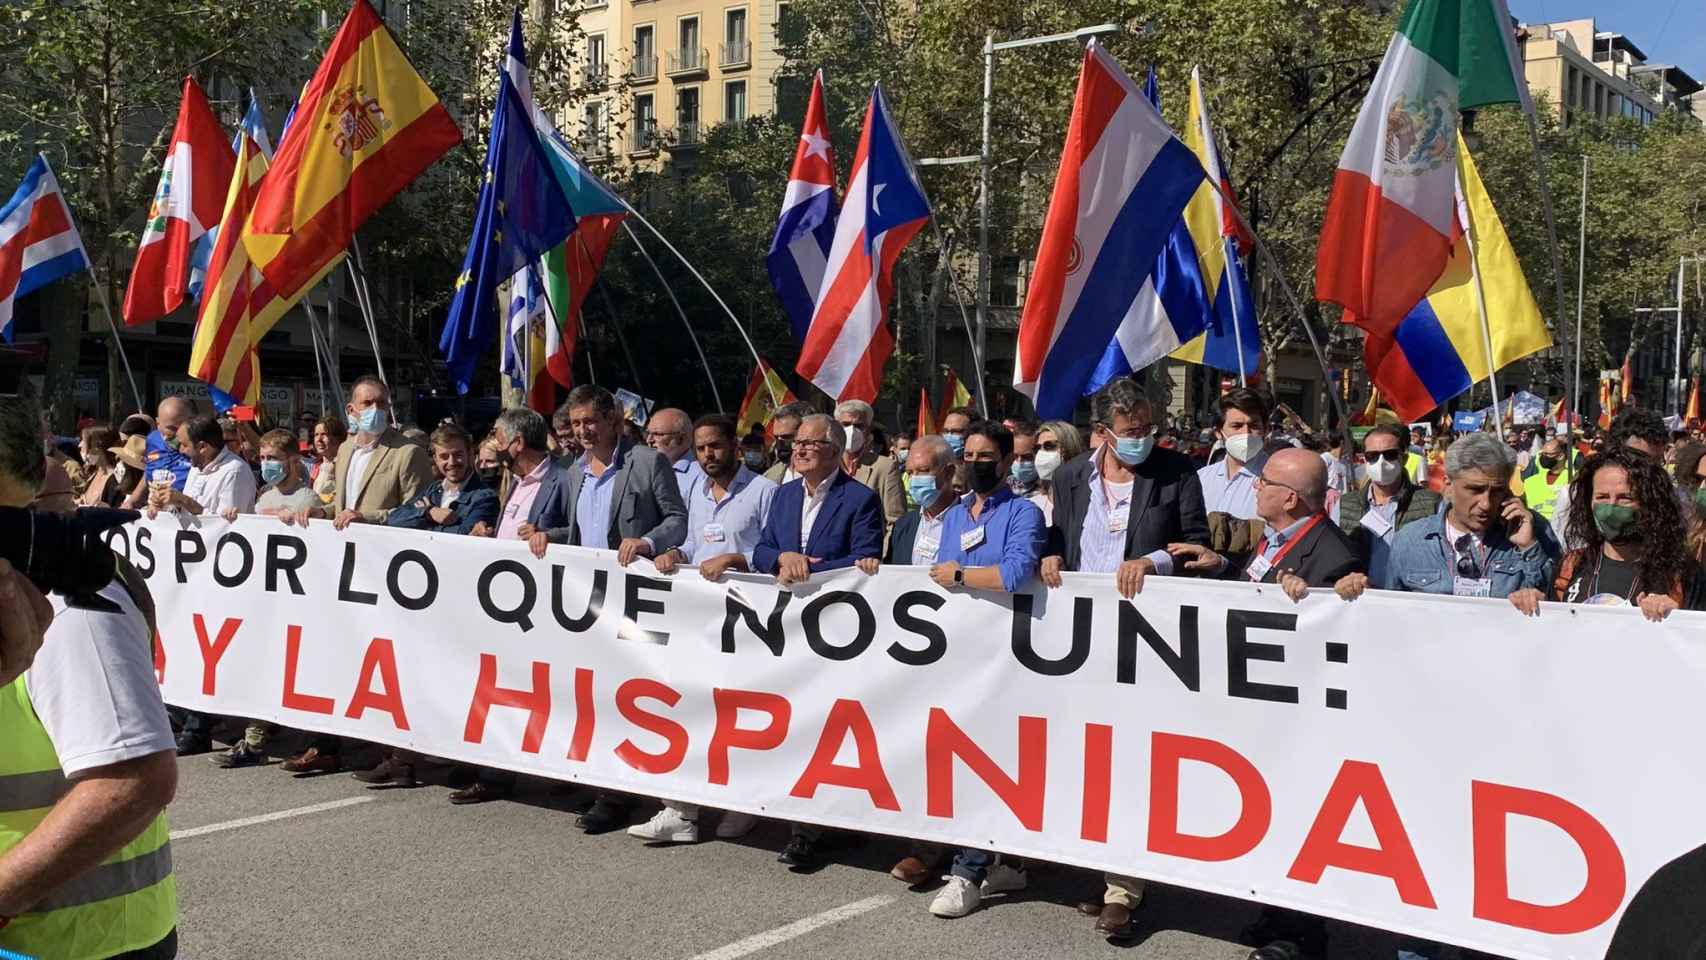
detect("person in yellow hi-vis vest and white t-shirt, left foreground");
top-left (0, 397), bottom-right (177, 960)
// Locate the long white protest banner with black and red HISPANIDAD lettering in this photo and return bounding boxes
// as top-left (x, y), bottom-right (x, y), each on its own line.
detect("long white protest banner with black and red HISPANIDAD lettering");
top-left (113, 517), bottom-right (1706, 958)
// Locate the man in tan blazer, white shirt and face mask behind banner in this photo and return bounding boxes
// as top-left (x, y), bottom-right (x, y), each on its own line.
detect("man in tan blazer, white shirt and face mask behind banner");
top-left (297, 375), bottom-right (432, 530)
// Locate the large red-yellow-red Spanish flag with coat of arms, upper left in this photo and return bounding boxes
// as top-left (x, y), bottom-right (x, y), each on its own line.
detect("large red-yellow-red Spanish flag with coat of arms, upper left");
top-left (242, 0), bottom-right (462, 307)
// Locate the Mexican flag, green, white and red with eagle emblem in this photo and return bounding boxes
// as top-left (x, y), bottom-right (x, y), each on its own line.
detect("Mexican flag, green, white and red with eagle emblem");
top-left (1315, 0), bottom-right (1532, 334)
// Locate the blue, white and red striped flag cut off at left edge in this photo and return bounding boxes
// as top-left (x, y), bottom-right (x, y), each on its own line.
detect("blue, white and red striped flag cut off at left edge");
top-left (0, 153), bottom-right (89, 343)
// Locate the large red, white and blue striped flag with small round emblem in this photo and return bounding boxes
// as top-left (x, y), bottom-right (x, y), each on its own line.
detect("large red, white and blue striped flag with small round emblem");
top-left (1013, 41), bottom-right (1204, 419)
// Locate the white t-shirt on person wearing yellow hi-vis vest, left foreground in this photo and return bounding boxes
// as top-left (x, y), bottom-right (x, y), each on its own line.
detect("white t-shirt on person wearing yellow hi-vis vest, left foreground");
top-left (24, 583), bottom-right (176, 778)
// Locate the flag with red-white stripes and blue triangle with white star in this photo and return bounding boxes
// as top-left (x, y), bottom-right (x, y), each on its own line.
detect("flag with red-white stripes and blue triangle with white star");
top-left (795, 84), bottom-right (928, 402)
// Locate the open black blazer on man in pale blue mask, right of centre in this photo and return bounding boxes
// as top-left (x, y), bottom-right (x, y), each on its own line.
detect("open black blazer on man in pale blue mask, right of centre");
top-left (1044, 447), bottom-right (1208, 570)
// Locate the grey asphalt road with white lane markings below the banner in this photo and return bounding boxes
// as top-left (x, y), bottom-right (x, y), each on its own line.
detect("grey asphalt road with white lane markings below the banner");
top-left (169, 736), bottom-right (1412, 960)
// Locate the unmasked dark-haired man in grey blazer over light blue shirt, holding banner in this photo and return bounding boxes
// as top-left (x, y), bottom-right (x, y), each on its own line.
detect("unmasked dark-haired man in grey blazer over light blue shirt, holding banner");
top-left (529, 384), bottom-right (688, 566)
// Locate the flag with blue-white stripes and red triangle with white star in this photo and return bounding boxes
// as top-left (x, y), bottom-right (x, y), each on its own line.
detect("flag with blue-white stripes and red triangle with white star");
top-left (764, 70), bottom-right (839, 344)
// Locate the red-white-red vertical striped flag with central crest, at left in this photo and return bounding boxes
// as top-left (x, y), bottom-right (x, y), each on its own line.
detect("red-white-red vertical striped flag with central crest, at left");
top-left (125, 77), bottom-right (237, 326)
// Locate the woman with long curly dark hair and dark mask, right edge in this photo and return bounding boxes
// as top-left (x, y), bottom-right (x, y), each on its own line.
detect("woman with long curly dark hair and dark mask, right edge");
top-left (1510, 447), bottom-right (1706, 621)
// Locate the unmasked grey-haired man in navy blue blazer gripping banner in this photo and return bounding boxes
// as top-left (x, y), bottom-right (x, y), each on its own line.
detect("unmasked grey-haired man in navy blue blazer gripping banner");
top-left (752, 414), bottom-right (887, 585)
